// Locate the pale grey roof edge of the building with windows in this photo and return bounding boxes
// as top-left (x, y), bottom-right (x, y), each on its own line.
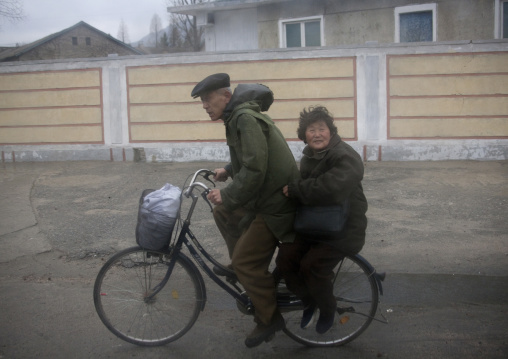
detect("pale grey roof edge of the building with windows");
top-left (167, 0), bottom-right (292, 16)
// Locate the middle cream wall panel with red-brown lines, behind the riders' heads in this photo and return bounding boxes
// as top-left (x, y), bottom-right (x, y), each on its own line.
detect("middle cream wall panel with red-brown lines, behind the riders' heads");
top-left (127, 57), bottom-right (357, 143)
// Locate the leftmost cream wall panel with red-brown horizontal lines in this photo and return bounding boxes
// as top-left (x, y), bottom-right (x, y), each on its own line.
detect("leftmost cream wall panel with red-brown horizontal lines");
top-left (0, 68), bottom-right (104, 145)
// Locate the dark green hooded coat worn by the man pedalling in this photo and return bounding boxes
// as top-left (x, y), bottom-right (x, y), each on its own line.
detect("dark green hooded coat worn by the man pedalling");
top-left (221, 85), bottom-right (299, 242)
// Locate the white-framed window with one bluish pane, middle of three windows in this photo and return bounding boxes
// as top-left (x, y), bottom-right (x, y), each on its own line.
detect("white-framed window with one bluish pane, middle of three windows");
top-left (395, 4), bottom-right (437, 42)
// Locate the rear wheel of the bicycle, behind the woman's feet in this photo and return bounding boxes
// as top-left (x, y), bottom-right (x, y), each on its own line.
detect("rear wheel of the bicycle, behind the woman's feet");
top-left (283, 256), bottom-right (379, 347)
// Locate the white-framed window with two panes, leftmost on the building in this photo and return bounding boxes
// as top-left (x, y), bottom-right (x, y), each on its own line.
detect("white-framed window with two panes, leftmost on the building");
top-left (279, 16), bottom-right (324, 47)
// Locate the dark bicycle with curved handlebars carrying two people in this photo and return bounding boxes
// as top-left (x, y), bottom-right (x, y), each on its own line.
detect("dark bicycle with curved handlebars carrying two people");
top-left (93, 169), bottom-right (384, 346)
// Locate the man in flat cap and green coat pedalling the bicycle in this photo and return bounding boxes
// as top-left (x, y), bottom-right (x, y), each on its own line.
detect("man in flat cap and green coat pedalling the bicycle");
top-left (191, 73), bottom-right (299, 348)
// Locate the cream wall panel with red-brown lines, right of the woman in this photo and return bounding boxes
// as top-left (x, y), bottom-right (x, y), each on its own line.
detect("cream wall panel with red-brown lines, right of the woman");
top-left (387, 52), bottom-right (508, 139)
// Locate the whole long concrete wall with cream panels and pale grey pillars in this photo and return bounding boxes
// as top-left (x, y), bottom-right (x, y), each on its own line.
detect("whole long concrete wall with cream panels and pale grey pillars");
top-left (0, 41), bottom-right (508, 162)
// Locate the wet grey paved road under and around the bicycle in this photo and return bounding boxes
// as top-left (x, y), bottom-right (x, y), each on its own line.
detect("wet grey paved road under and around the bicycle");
top-left (0, 161), bottom-right (508, 359)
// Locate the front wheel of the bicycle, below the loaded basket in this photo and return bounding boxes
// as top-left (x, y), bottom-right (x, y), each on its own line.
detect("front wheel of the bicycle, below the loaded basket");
top-left (93, 247), bottom-right (204, 346)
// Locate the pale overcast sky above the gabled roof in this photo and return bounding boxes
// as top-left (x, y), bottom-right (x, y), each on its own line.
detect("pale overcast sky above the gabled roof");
top-left (0, 0), bottom-right (168, 46)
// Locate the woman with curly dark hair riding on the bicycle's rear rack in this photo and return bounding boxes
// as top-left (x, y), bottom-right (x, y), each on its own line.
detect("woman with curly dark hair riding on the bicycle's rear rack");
top-left (277, 106), bottom-right (367, 334)
